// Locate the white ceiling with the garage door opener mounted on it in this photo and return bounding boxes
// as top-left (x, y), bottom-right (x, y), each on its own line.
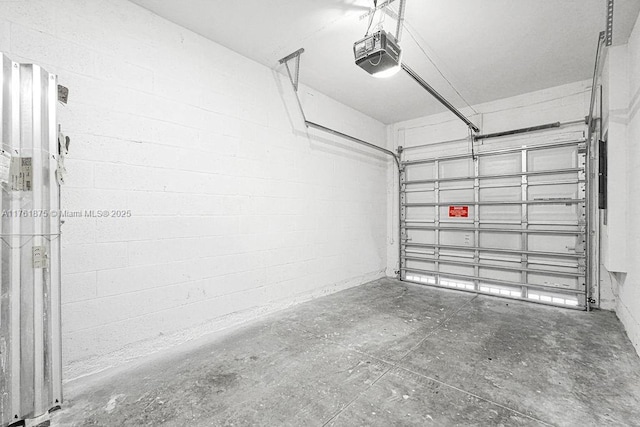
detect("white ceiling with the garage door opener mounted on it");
top-left (132, 0), bottom-right (640, 124)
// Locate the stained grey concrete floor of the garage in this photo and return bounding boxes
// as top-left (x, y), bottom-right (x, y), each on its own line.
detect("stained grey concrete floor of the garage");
top-left (52, 279), bottom-right (640, 427)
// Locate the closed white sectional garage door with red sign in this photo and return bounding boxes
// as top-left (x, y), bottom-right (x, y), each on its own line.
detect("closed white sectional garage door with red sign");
top-left (400, 129), bottom-right (587, 309)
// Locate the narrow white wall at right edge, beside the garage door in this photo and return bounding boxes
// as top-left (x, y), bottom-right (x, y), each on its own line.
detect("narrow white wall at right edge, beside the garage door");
top-left (602, 10), bottom-right (640, 354)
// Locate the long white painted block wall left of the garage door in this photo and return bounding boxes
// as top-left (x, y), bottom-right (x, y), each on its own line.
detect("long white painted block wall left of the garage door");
top-left (0, 0), bottom-right (390, 379)
